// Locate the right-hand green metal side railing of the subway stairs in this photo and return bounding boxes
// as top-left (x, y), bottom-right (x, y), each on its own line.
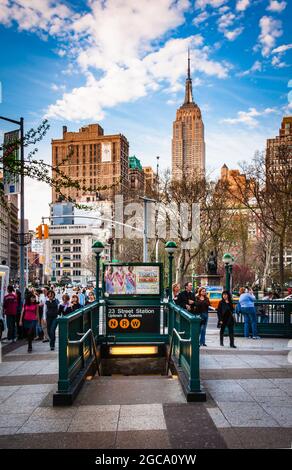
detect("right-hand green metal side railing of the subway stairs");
top-left (168, 302), bottom-right (205, 400)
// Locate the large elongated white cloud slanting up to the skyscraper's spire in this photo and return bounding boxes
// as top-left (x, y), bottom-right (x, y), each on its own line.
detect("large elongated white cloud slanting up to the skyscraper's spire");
top-left (47, 35), bottom-right (229, 120)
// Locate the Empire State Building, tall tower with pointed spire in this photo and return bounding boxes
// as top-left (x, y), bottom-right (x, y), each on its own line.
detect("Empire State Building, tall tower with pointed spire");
top-left (172, 54), bottom-right (205, 180)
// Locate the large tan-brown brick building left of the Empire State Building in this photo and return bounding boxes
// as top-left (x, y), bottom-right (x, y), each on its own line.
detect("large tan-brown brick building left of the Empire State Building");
top-left (52, 124), bottom-right (129, 203)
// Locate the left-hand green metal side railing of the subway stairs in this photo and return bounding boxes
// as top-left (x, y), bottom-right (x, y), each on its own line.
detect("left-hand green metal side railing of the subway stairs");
top-left (58, 302), bottom-right (104, 393)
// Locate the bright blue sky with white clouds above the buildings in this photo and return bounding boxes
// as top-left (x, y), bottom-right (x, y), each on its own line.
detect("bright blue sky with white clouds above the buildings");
top-left (0, 0), bottom-right (292, 228)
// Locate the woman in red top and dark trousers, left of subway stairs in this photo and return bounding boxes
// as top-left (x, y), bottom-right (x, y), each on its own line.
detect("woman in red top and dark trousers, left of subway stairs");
top-left (19, 292), bottom-right (40, 353)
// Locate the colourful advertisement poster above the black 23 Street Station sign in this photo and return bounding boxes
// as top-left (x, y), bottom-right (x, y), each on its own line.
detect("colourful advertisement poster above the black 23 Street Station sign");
top-left (104, 265), bottom-right (160, 295)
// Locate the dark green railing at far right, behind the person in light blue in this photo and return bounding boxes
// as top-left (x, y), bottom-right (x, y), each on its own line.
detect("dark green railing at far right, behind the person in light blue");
top-left (234, 299), bottom-right (292, 338)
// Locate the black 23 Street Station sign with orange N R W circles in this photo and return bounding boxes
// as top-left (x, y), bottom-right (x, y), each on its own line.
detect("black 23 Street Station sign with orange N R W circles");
top-left (106, 306), bottom-right (160, 335)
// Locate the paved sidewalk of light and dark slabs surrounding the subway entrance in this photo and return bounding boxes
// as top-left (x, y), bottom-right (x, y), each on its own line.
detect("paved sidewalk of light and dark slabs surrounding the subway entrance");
top-left (0, 327), bottom-right (292, 449)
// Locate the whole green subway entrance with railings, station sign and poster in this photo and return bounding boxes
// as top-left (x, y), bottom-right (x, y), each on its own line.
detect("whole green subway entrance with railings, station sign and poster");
top-left (53, 263), bottom-right (206, 406)
